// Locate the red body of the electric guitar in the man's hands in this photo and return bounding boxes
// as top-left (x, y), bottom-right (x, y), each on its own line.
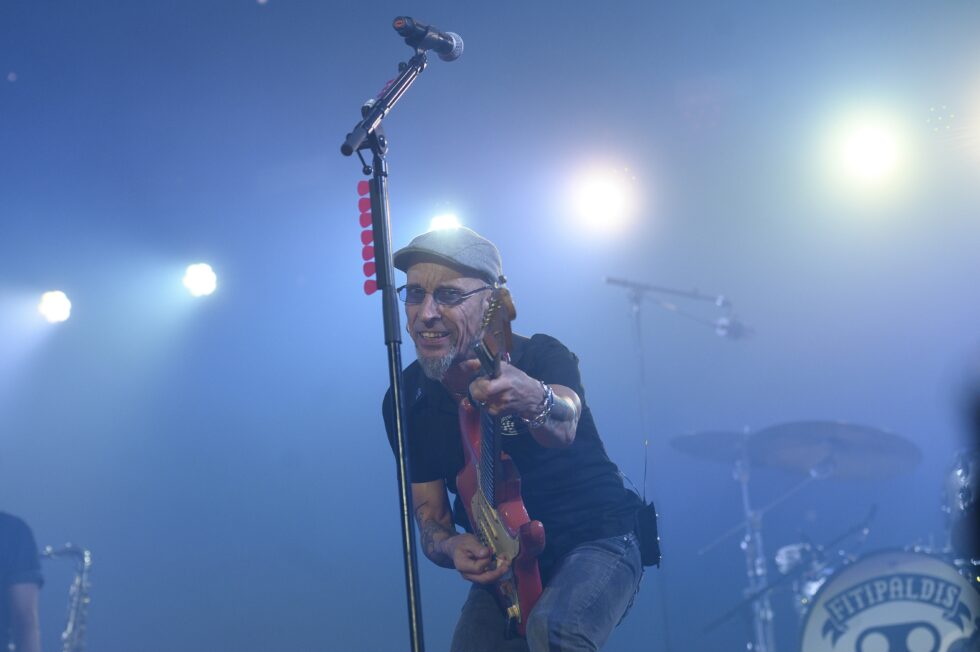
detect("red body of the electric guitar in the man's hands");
top-left (456, 399), bottom-right (545, 636)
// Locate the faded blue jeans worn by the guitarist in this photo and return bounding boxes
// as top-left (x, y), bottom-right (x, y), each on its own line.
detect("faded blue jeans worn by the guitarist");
top-left (450, 533), bottom-right (643, 652)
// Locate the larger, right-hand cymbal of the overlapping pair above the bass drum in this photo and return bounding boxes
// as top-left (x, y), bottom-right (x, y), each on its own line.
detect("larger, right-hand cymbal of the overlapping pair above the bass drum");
top-left (748, 421), bottom-right (922, 479)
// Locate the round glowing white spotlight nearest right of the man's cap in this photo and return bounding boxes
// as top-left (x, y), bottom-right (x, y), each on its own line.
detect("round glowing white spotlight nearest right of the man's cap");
top-left (569, 168), bottom-right (637, 232)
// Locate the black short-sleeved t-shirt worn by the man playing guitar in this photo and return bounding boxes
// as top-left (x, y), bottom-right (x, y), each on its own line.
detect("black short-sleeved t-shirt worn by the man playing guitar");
top-left (383, 335), bottom-right (642, 567)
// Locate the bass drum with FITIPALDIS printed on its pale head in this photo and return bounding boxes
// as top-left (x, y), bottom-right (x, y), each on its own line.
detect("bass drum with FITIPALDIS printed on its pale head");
top-left (800, 551), bottom-right (980, 652)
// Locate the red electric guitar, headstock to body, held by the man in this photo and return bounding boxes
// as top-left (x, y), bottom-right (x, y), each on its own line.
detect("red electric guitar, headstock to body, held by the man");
top-left (456, 288), bottom-right (544, 636)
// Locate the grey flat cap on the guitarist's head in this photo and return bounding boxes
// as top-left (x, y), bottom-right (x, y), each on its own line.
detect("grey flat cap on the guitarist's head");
top-left (393, 226), bottom-right (503, 284)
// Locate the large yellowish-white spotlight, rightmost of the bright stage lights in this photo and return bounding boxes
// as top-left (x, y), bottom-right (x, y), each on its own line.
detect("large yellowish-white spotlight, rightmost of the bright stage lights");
top-left (831, 111), bottom-right (909, 191)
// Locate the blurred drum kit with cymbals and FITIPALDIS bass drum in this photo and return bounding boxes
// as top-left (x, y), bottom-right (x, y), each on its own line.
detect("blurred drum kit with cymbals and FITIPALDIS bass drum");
top-left (670, 421), bottom-right (980, 652)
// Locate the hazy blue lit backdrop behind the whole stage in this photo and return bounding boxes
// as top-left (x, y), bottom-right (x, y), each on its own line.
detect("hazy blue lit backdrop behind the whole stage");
top-left (0, 0), bottom-right (980, 652)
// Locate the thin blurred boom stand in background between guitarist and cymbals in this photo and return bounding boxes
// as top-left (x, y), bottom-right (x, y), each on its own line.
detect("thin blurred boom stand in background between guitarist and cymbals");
top-left (606, 277), bottom-right (749, 652)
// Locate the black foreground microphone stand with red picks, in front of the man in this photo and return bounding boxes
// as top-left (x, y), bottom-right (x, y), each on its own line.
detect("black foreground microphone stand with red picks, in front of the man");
top-left (340, 49), bottom-right (426, 652)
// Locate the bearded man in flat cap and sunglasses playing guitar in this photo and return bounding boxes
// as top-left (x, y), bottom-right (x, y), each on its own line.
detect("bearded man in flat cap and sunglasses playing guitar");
top-left (383, 227), bottom-right (659, 652)
